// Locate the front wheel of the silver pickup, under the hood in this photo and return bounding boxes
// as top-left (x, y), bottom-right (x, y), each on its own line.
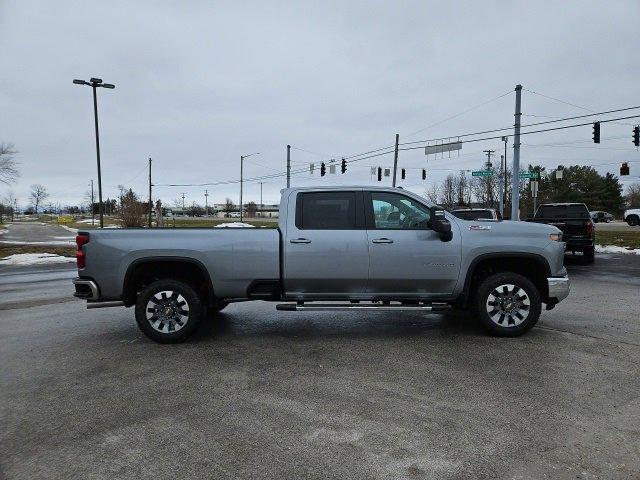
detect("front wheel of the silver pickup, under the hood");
top-left (473, 272), bottom-right (542, 337)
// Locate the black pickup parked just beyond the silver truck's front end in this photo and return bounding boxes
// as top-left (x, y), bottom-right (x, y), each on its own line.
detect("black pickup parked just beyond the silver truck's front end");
top-left (529, 203), bottom-right (595, 263)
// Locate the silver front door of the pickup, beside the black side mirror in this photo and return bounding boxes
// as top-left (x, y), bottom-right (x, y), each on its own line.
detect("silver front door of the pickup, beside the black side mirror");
top-left (364, 191), bottom-right (462, 298)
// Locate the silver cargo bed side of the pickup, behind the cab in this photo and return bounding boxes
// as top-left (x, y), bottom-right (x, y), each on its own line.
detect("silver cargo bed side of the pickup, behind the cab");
top-left (79, 228), bottom-right (280, 299)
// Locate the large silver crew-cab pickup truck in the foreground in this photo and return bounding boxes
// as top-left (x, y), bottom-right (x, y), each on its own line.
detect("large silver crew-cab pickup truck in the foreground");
top-left (74, 187), bottom-right (569, 343)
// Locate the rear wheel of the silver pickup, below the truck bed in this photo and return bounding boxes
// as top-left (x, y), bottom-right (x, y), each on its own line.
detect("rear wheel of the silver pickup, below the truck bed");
top-left (136, 279), bottom-right (202, 343)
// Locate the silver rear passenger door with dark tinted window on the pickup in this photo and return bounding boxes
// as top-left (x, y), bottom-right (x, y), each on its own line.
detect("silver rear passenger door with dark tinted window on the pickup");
top-left (283, 191), bottom-right (369, 299)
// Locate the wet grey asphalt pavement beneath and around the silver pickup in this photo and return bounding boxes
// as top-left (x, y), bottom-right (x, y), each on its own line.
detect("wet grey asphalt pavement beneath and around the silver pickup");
top-left (0, 254), bottom-right (640, 479)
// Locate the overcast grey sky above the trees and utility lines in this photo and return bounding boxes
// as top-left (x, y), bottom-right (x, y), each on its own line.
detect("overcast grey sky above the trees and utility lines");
top-left (0, 0), bottom-right (640, 207)
